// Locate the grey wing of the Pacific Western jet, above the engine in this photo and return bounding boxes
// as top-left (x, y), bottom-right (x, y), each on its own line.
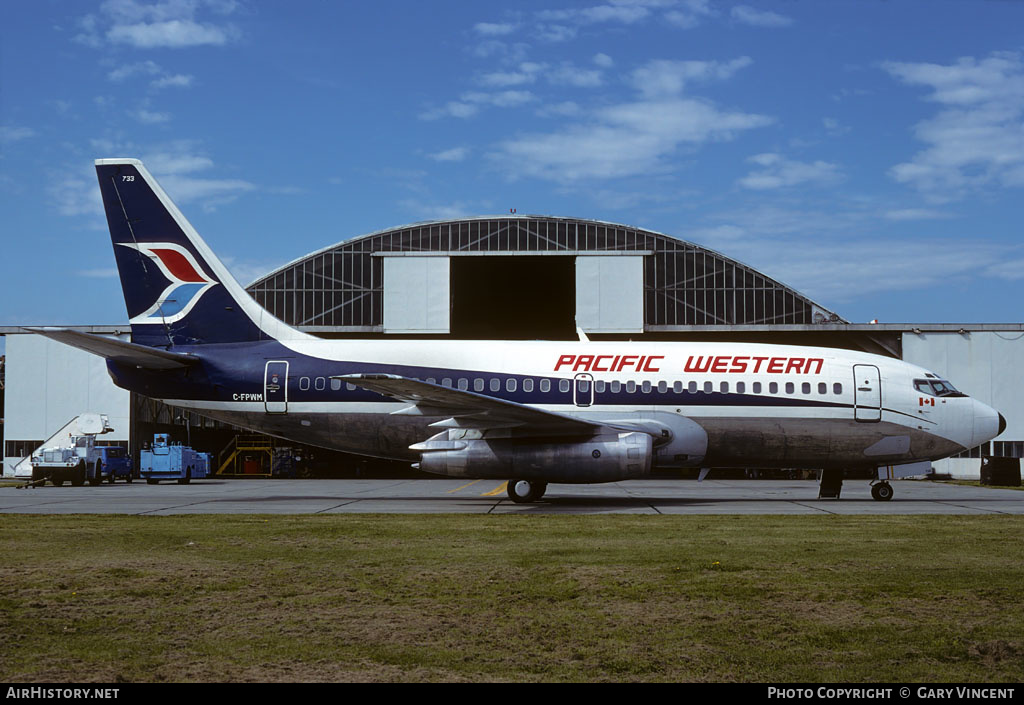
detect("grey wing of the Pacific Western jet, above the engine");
top-left (336, 374), bottom-right (606, 437)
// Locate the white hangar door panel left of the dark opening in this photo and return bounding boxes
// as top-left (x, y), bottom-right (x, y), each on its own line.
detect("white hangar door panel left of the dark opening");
top-left (384, 256), bottom-right (451, 333)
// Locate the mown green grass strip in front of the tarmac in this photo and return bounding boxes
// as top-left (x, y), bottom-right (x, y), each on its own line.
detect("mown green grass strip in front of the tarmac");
top-left (0, 514), bottom-right (1024, 682)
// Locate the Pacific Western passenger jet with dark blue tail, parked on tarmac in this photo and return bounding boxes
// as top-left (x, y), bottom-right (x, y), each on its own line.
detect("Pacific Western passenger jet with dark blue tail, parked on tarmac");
top-left (33, 159), bottom-right (1006, 503)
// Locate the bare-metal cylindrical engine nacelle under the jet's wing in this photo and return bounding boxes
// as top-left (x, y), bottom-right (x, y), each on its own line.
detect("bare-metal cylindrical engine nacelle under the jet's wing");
top-left (411, 431), bottom-right (653, 484)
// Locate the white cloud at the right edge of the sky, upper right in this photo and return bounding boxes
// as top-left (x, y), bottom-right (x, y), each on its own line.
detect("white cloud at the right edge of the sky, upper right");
top-left (883, 52), bottom-right (1024, 202)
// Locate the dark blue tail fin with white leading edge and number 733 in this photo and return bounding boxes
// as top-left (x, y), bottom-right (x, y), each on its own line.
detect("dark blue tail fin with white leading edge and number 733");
top-left (96, 159), bottom-right (306, 347)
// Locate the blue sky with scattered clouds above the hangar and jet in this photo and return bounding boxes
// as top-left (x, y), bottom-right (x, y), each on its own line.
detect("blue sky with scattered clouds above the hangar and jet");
top-left (0, 0), bottom-right (1024, 334)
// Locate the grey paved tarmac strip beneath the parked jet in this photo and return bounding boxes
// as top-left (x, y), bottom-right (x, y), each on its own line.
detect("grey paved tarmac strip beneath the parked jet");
top-left (0, 478), bottom-right (1024, 515)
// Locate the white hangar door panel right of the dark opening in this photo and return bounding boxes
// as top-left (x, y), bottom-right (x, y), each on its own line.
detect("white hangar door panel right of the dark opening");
top-left (575, 255), bottom-right (643, 333)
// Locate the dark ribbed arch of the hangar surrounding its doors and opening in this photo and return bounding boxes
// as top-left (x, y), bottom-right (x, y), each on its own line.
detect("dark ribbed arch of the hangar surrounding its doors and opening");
top-left (247, 215), bottom-right (845, 332)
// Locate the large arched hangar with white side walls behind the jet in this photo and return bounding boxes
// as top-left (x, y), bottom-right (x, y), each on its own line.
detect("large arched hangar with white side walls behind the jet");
top-left (0, 215), bottom-right (1024, 478)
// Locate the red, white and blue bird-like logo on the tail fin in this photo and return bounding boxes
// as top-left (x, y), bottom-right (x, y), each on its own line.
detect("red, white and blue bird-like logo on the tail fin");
top-left (118, 243), bottom-right (218, 324)
